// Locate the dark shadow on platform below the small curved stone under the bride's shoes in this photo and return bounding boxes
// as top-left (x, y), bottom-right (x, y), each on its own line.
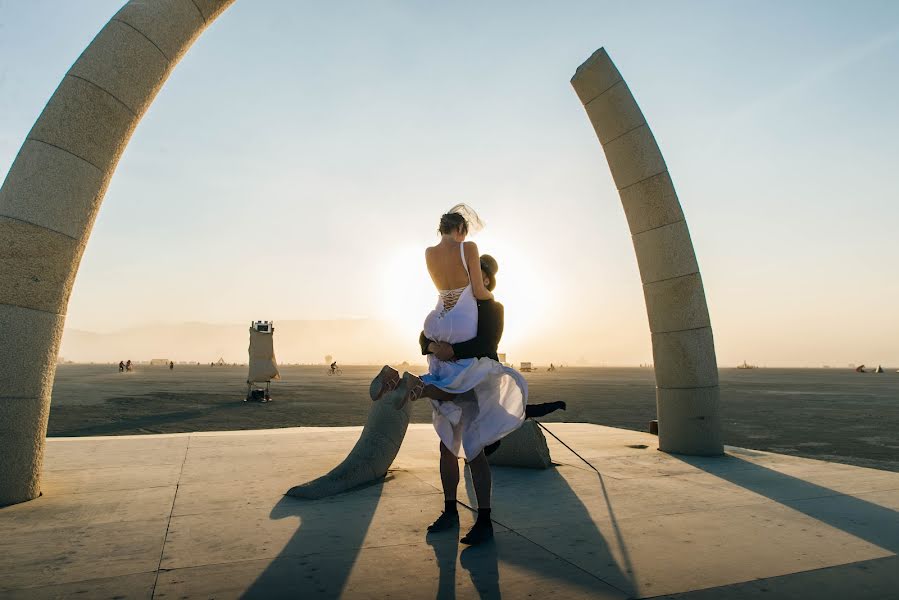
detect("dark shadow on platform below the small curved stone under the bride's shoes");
top-left (241, 475), bottom-right (392, 599)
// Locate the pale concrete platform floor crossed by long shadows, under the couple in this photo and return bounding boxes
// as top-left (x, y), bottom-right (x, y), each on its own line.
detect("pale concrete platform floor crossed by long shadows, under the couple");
top-left (0, 423), bottom-right (899, 599)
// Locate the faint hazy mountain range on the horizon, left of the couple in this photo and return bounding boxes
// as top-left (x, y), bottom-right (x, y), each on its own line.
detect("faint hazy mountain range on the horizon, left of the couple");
top-left (60, 319), bottom-right (422, 364)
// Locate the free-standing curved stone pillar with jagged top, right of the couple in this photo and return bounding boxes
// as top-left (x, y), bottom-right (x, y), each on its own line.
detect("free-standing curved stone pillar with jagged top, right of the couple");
top-left (571, 48), bottom-right (723, 455)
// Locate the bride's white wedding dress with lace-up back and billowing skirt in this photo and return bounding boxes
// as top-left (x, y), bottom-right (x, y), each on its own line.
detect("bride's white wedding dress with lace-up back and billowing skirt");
top-left (421, 244), bottom-right (528, 460)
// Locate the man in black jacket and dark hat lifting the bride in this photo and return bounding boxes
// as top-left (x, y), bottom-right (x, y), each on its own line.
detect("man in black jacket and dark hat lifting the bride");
top-left (418, 254), bottom-right (565, 545)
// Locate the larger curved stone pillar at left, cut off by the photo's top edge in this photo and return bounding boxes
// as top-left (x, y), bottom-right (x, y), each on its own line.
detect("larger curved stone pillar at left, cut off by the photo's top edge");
top-left (0, 0), bottom-right (234, 506)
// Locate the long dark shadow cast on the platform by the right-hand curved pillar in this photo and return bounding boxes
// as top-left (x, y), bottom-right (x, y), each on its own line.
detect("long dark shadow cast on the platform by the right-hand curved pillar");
top-left (672, 454), bottom-right (899, 553)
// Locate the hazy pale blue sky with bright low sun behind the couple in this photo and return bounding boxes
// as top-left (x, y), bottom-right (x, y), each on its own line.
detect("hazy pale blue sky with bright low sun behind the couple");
top-left (0, 0), bottom-right (899, 366)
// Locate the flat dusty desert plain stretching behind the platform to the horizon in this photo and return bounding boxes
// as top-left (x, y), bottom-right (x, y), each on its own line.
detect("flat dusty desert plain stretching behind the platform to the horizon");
top-left (48, 365), bottom-right (899, 471)
